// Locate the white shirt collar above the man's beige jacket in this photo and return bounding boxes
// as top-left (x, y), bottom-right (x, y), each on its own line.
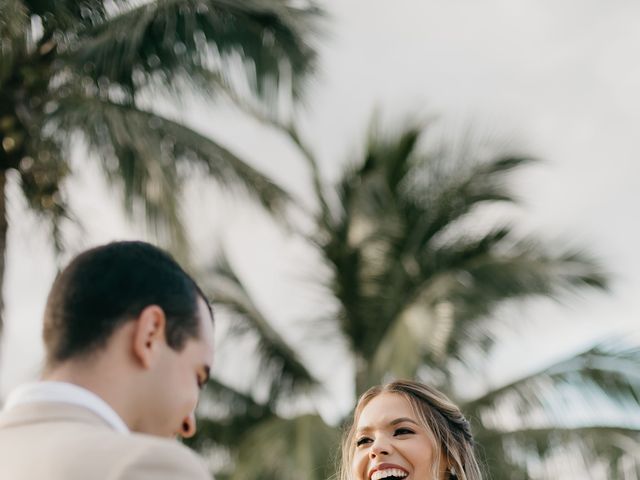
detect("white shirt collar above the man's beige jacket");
top-left (4, 381), bottom-right (129, 433)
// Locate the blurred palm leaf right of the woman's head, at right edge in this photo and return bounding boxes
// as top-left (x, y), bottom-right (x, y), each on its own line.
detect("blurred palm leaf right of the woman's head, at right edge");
top-left (461, 341), bottom-right (640, 479)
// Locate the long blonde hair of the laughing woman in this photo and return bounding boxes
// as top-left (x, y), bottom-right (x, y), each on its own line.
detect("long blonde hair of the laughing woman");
top-left (338, 380), bottom-right (482, 480)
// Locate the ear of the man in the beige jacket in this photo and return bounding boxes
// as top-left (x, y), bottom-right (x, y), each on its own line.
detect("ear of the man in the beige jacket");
top-left (133, 305), bottom-right (167, 368)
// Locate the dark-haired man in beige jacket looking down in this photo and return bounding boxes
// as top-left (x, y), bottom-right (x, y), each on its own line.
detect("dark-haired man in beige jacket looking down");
top-left (0, 242), bottom-right (213, 480)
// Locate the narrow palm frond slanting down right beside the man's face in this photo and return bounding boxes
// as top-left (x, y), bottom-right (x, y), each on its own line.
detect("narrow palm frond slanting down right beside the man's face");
top-left (202, 255), bottom-right (317, 401)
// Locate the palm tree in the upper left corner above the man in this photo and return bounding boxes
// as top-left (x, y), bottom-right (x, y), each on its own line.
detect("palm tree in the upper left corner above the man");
top-left (0, 0), bottom-right (319, 340)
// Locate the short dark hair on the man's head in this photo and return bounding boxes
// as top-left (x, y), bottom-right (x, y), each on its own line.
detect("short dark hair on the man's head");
top-left (43, 242), bottom-right (212, 365)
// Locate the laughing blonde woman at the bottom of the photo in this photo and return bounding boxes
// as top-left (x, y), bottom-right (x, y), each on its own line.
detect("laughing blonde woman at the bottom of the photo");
top-left (340, 380), bottom-right (482, 480)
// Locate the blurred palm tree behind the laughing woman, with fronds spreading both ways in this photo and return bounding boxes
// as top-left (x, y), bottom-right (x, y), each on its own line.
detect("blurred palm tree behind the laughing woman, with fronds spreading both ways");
top-left (194, 117), bottom-right (640, 480)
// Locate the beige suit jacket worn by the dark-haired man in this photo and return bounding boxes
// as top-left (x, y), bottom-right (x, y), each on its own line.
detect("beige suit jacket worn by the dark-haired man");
top-left (0, 403), bottom-right (211, 480)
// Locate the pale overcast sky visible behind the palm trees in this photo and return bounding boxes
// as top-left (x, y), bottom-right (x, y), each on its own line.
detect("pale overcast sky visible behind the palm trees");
top-left (0, 0), bottom-right (640, 417)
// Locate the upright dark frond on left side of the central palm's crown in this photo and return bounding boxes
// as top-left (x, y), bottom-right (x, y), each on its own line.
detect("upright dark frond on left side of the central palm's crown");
top-left (319, 122), bottom-right (422, 359)
